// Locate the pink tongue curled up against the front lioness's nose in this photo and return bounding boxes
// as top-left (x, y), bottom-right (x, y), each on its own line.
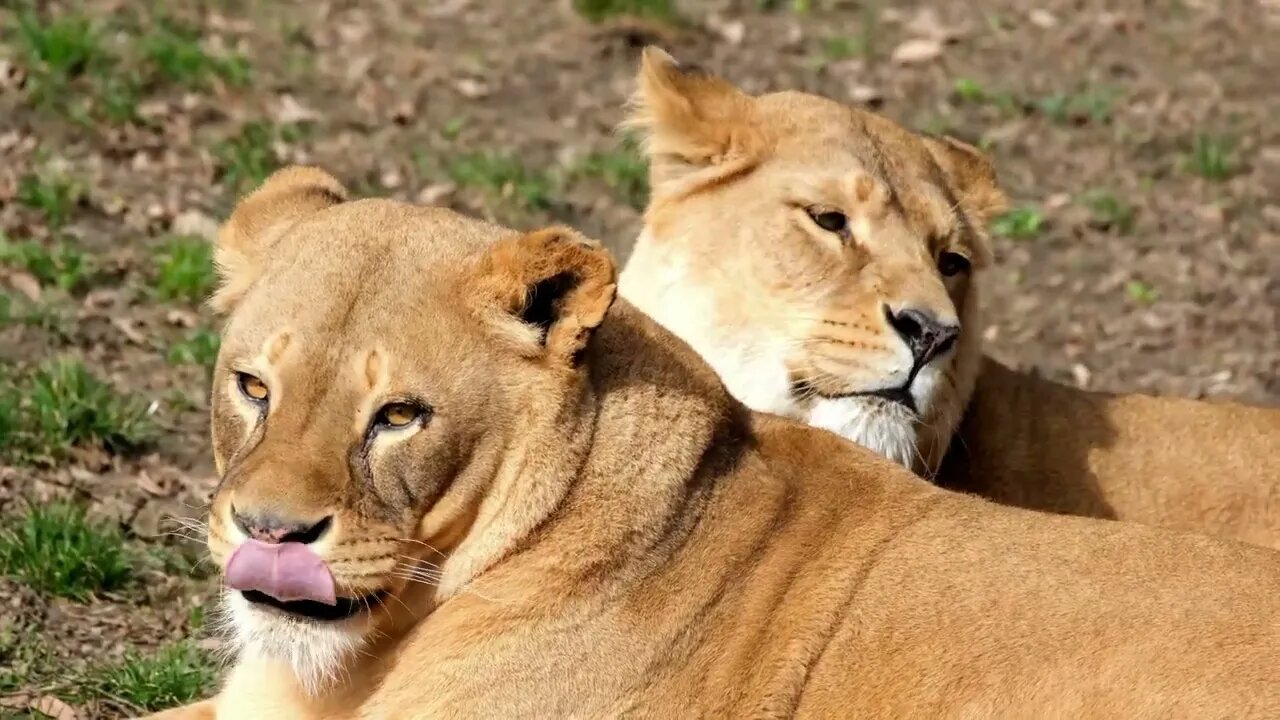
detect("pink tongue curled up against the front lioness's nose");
top-left (227, 539), bottom-right (338, 605)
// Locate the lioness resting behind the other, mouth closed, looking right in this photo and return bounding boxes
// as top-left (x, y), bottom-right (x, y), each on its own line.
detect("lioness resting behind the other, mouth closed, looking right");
top-left (620, 49), bottom-right (1280, 547)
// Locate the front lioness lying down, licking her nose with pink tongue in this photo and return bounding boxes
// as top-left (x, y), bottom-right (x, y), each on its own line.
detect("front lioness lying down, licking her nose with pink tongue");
top-left (149, 168), bottom-right (1280, 720)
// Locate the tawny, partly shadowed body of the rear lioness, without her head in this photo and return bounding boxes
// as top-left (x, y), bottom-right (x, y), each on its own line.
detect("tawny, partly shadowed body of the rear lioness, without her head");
top-left (937, 359), bottom-right (1280, 548)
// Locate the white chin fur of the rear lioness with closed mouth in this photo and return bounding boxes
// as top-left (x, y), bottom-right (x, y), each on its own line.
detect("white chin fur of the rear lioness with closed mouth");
top-left (805, 397), bottom-right (924, 470)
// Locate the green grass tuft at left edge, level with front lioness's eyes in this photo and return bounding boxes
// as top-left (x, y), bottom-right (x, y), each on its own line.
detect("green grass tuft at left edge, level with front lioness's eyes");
top-left (0, 357), bottom-right (154, 465)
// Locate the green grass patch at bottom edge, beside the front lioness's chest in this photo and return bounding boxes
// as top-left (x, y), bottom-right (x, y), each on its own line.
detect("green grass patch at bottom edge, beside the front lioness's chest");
top-left (84, 642), bottom-right (218, 711)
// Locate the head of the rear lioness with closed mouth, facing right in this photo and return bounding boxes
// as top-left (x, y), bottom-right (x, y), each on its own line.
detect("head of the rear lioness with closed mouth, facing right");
top-left (621, 49), bottom-right (1004, 473)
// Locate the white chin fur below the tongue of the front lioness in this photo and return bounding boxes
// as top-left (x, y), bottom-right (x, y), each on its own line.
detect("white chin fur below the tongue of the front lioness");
top-left (223, 591), bottom-right (364, 694)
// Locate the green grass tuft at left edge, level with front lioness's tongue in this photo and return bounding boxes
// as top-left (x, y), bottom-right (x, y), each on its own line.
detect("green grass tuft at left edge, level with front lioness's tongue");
top-left (0, 502), bottom-right (132, 602)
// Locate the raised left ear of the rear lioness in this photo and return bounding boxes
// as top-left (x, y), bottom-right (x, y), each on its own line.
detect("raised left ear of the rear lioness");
top-left (625, 46), bottom-right (765, 191)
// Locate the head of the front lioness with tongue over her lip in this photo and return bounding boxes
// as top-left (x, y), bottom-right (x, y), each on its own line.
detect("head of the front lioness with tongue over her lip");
top-left (209, 168), bottom-right (614, 688)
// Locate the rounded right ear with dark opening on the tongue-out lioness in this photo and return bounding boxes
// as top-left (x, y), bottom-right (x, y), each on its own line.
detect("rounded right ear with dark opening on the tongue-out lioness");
top-left (476, 227), bottom-right (617, 365)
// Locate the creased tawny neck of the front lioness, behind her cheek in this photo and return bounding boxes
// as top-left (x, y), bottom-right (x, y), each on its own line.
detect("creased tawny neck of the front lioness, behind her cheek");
top-left (436, 301), bottom-right (746, 603)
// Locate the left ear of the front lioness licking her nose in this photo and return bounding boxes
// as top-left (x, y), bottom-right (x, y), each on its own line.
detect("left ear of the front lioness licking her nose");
top-left (209, 165), bottom-right (347, 313)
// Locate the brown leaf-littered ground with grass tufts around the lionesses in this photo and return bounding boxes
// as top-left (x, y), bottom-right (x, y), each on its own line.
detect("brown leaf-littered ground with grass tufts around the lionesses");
top-left (0, 0), bottom-right (1280, 717)
